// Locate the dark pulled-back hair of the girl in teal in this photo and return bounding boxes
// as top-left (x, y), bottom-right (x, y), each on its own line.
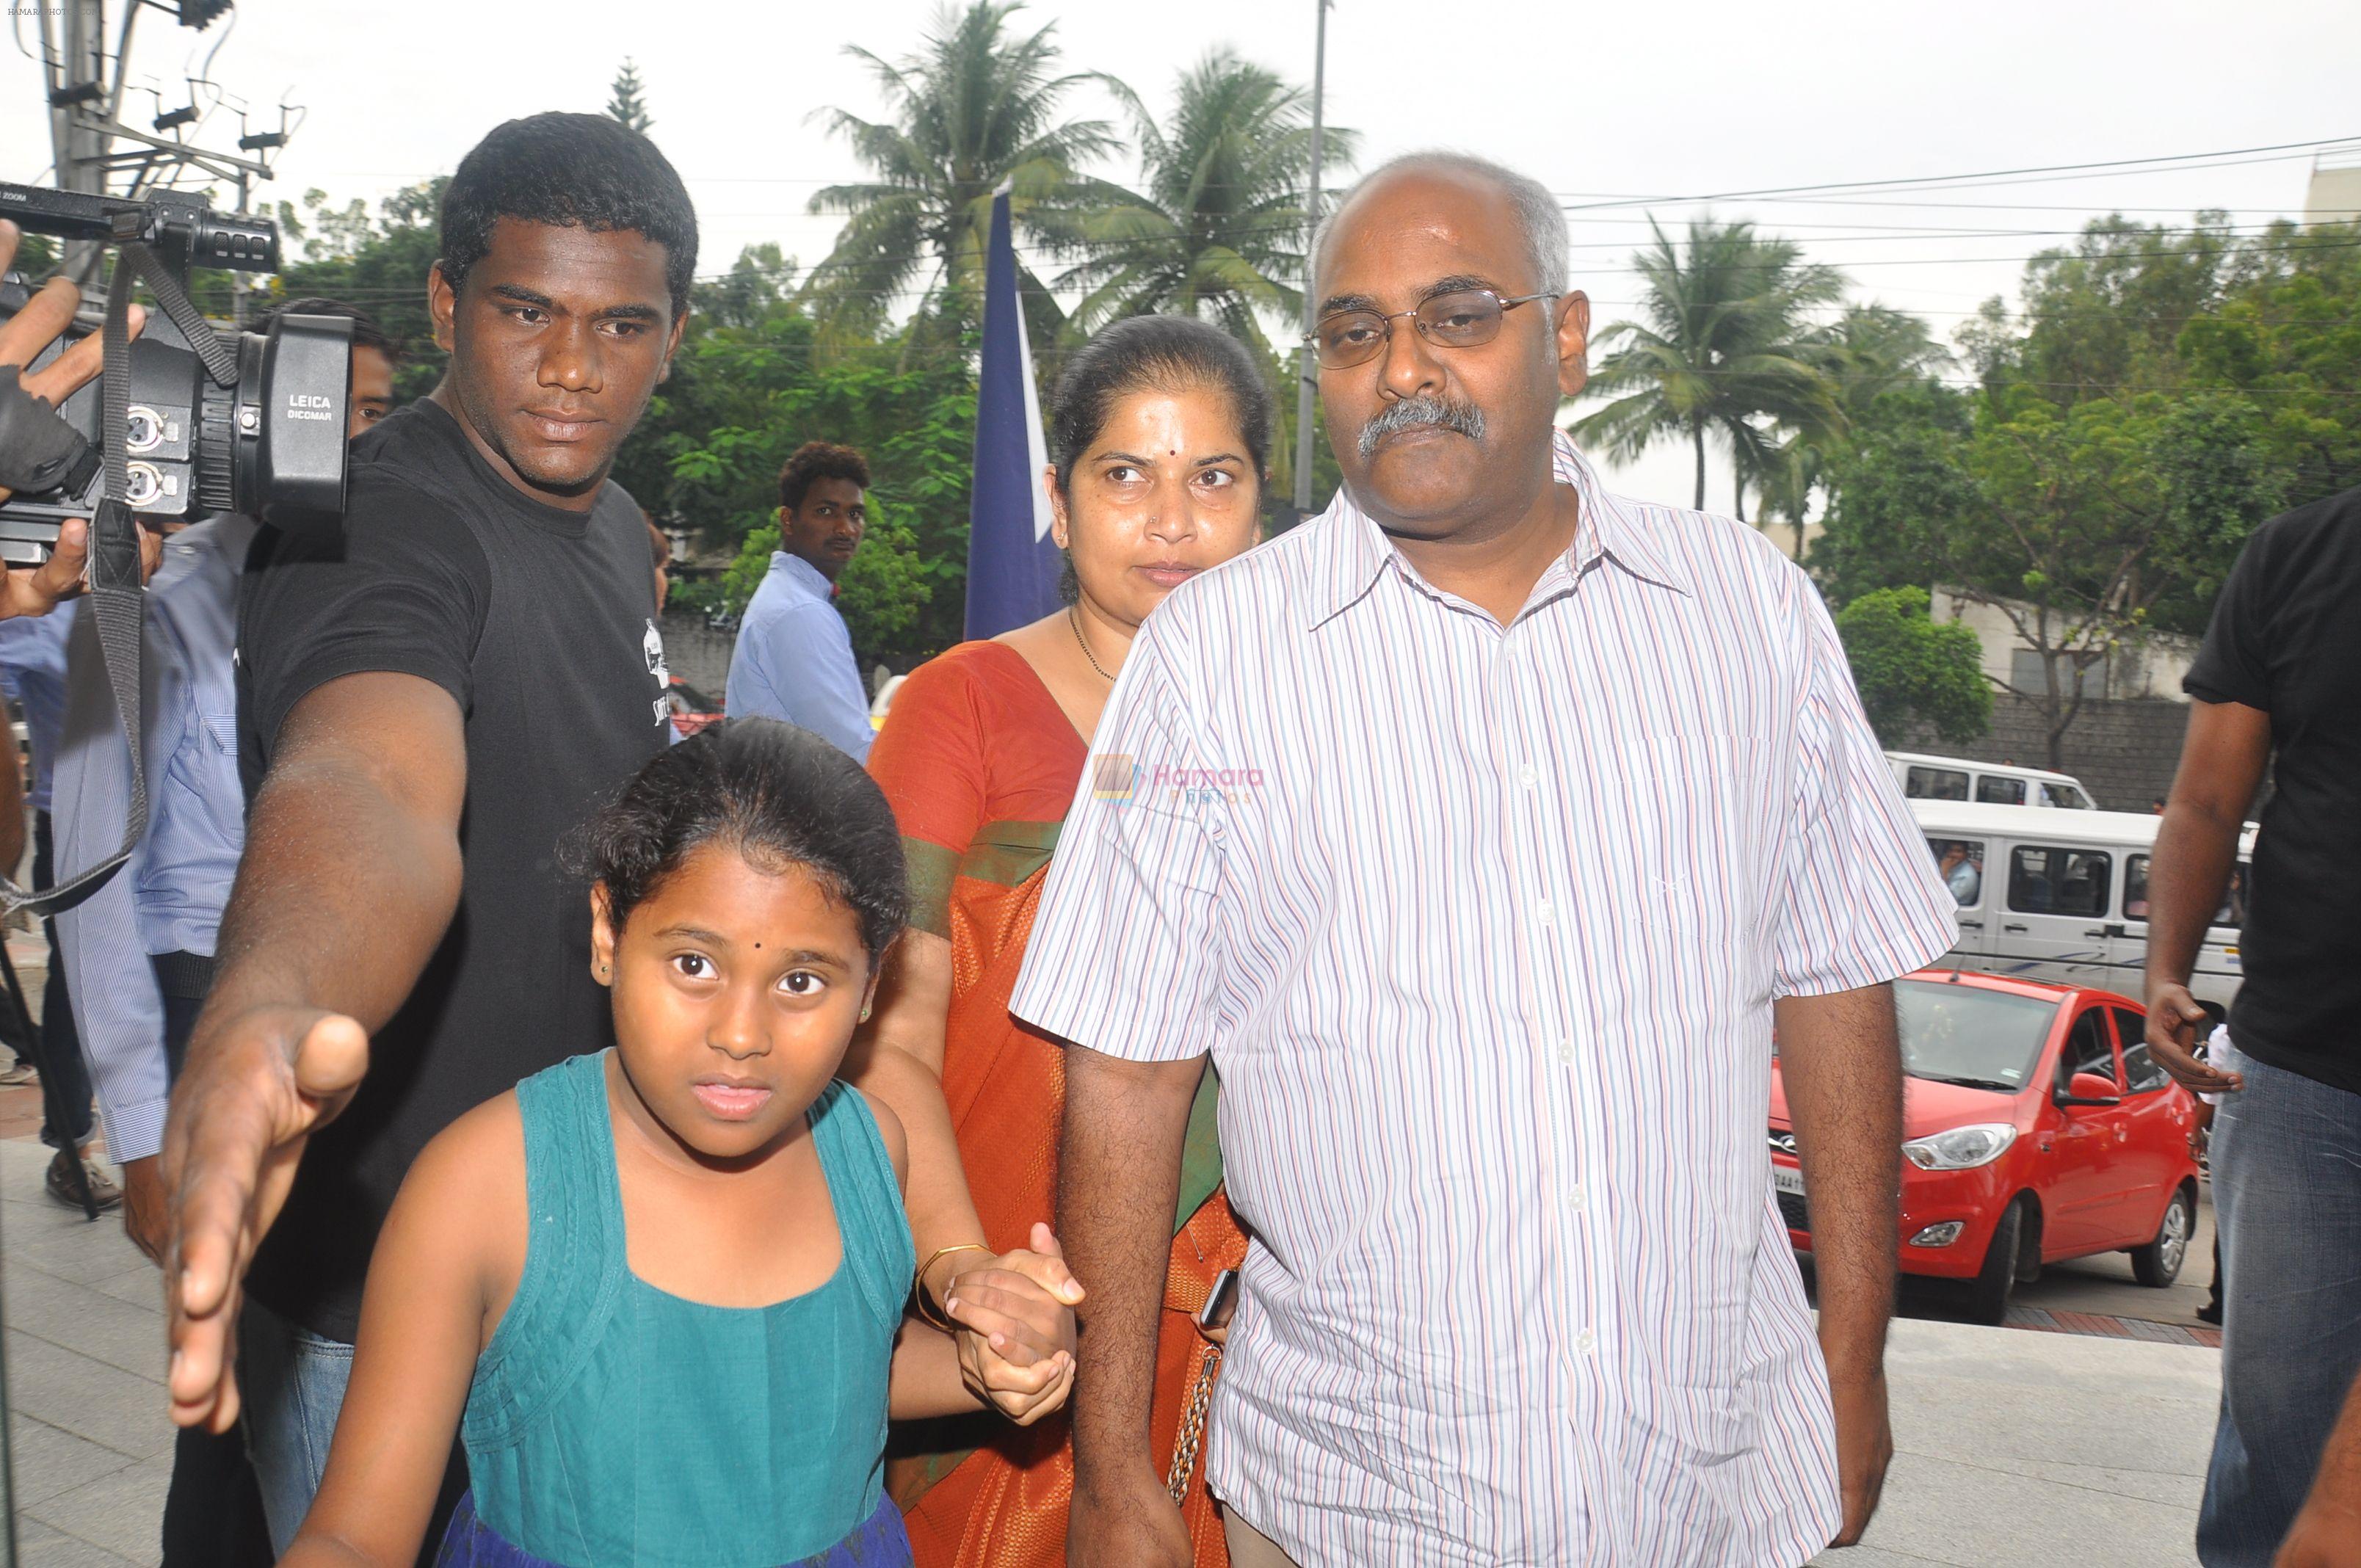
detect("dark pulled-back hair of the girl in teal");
top-left (573, 718), bottom-right (909, 966)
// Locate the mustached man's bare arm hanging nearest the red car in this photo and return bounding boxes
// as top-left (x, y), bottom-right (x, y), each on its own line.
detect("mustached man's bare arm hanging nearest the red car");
top-left (1773, 984), bottom-right (1903, 1547)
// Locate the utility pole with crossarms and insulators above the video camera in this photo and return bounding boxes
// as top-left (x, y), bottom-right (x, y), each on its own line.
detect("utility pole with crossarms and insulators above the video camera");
top-left (29, 0), bottom-right (288, 290)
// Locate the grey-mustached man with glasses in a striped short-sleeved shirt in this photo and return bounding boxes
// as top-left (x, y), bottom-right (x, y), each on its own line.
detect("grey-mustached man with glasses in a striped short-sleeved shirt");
top-left (1010, 153), bottom-right (1955, 1568)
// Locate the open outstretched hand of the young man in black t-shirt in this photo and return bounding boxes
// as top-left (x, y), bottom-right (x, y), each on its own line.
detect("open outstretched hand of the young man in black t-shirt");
top-left (163, 1009), bottom-right (369, 1431)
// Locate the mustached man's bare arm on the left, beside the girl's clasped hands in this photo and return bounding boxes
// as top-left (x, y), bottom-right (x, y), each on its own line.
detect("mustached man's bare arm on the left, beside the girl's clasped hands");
top-left (1058, 1046), bottom-right (1206, 1568)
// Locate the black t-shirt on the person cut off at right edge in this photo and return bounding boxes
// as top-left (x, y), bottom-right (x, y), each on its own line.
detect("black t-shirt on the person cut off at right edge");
top-left (2182, 489), bottom-right (2361, 1091)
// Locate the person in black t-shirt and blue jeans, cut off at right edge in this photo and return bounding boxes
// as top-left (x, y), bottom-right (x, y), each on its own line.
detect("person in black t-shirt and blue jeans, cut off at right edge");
top-left (2149, 489), bottom-right (2361, 1568)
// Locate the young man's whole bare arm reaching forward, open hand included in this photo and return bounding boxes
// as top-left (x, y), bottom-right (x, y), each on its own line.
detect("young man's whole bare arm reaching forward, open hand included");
top-left (163, 673), bottom-right (468, 1431)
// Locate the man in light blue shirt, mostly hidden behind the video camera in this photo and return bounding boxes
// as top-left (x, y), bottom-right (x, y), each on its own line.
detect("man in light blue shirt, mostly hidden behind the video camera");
top-left (54, 300), bottom-right (394, 1568)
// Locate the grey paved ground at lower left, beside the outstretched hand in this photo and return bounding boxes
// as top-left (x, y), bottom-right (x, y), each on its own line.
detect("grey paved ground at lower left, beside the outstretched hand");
top-left (0, 1139), bottom-right (173, 1568)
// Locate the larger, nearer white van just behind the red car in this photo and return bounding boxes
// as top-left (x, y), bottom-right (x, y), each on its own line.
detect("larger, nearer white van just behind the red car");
top-left (1910, 798), bottom-right (2255, 1020)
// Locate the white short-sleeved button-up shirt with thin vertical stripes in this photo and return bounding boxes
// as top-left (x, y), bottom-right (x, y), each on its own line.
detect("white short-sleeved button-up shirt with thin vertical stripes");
top-left (1010, 439), bottom-right (1955, 1568)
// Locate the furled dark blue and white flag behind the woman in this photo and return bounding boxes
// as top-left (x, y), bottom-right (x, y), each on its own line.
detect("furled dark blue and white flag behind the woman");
top-left (968, 184), bottom-right (1060, 640)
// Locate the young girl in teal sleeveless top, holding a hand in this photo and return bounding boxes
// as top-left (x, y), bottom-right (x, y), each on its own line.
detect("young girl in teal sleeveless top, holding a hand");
top-left (283, 720), bottom-right (1072, 1568)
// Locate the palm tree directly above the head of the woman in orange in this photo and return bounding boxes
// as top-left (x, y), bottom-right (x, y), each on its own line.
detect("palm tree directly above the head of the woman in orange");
top-left (1058, 47), bottom-right (1357, 355)
